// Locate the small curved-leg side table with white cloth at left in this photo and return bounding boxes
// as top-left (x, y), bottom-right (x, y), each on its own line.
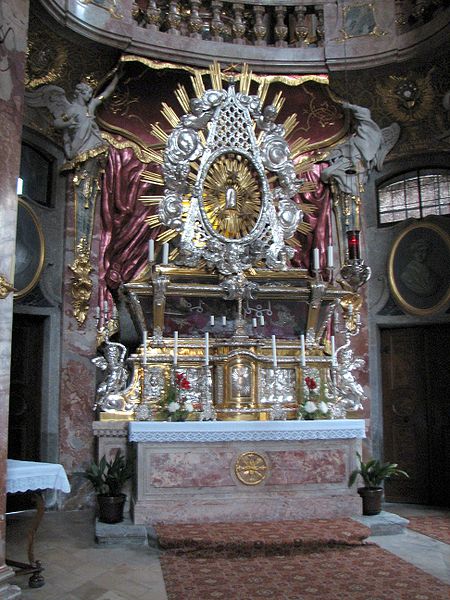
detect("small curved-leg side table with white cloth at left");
top-left (6, 459), bottom-right (70, 587)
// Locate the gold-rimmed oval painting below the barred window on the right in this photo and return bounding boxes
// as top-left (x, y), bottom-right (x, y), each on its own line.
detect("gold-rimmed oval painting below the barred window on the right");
top-left (389, 221), bottom-right (450, 316)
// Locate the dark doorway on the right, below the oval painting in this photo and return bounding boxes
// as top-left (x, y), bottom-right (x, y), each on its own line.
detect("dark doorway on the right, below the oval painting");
top-left (381, 323), bottom-right (450, 506)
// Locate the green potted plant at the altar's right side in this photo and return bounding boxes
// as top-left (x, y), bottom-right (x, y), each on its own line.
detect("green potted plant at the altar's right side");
top-left (348, 452), bottom-right (409, 515)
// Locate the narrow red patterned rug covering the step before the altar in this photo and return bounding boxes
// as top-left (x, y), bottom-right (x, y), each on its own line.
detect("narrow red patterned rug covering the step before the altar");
top-left (155, 518), bottom-right (370, 558)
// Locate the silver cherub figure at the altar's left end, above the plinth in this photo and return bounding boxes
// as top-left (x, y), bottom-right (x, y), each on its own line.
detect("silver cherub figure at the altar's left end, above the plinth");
top-left (92, 340), bottom-right (128, 412)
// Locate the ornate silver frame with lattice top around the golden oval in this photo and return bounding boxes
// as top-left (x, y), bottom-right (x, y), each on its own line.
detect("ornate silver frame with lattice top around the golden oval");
top-left (159, 85), bottom-right (303, 275)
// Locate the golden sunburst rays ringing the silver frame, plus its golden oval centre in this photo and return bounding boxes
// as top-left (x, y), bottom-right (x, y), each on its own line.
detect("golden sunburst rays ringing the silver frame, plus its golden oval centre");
top-left (141, 62), bottom-right (315, 258)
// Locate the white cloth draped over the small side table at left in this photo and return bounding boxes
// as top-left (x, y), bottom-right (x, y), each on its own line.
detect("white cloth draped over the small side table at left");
top-left (6, 458), bottom-right (70, 493)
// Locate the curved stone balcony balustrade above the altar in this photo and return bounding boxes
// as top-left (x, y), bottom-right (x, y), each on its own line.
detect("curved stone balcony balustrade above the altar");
top-left (40, 0), bottom-right (450, 74)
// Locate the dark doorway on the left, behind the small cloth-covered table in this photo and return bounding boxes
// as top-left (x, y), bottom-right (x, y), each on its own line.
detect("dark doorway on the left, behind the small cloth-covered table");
top-left (7, 313), bottom-right (45, 512)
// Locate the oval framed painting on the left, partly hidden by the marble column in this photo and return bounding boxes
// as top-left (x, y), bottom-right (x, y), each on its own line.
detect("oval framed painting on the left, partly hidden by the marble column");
top-left (14, 198), bottom-right (45, 299)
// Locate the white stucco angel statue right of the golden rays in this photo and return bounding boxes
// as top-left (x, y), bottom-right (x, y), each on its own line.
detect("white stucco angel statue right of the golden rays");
top-left (320, 102), bottom-right (400, 196)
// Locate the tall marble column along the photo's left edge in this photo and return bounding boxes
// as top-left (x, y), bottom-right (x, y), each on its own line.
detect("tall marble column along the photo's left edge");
top-left (0, 0), bottom-right (29, 599)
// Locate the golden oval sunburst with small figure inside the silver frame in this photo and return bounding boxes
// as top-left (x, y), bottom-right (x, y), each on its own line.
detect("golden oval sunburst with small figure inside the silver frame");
top-left (203, 153), bottom-right (262, 240)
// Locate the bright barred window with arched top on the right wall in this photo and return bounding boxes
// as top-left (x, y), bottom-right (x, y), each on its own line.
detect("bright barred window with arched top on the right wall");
top-left (378, 169), bottom-right (450, 225)
